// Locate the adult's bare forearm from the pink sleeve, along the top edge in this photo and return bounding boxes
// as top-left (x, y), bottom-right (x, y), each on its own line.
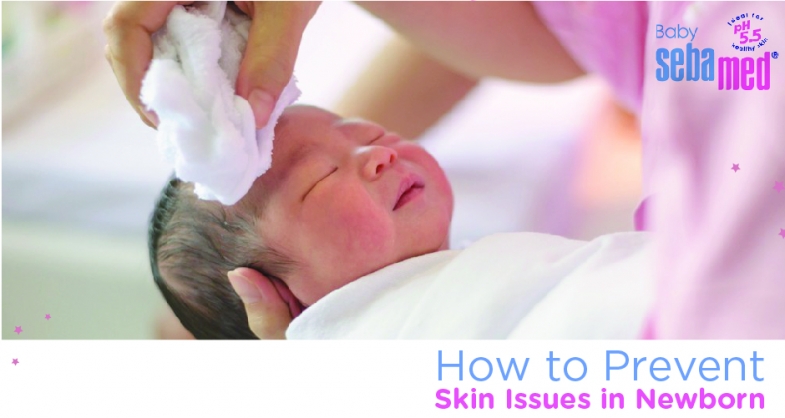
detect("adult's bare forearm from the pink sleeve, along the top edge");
top-left (357, 1), bottom-right (584, 83)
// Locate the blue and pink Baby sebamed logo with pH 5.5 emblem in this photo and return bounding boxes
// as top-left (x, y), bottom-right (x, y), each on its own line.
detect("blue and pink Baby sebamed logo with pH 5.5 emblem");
top-left (655, 13), bottom-right (779, 90)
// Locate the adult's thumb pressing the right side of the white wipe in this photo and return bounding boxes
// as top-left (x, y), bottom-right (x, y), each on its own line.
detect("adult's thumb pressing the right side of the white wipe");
top-left (236, 1), bottom-right (320, 129)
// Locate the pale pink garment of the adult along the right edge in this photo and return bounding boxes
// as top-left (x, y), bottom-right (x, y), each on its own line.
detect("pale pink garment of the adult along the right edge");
top-left (536, 2), bottom-right (785, 339)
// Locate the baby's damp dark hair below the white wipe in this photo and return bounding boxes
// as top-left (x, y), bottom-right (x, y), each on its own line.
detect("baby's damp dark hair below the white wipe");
top-left (148, 177), bottom-right (292, 339)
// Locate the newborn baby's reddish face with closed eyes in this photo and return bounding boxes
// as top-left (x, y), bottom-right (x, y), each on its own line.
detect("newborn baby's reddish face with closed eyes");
top-left (249, 106), bottom-right (453, 305)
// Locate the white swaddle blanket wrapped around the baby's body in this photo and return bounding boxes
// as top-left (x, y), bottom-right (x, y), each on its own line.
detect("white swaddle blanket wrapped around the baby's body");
top-left (286, 232), bottom-right (653, 339)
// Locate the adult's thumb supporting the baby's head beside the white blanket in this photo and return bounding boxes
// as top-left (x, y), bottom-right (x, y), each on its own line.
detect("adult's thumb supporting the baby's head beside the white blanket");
top-left (229, 268), bottom-right (304, 340)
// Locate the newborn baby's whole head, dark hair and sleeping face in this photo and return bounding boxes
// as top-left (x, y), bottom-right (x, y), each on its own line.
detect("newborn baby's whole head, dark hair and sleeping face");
top-left (149, 106), bottom-right (453, 339)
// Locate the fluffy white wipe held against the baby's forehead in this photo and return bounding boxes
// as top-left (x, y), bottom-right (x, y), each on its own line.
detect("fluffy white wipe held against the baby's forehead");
top-left (141, 2), bottom-right (300, 205)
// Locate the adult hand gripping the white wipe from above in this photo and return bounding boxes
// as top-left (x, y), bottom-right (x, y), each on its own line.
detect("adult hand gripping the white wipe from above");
top-left (104, 1), bottom-right (320, 128)
